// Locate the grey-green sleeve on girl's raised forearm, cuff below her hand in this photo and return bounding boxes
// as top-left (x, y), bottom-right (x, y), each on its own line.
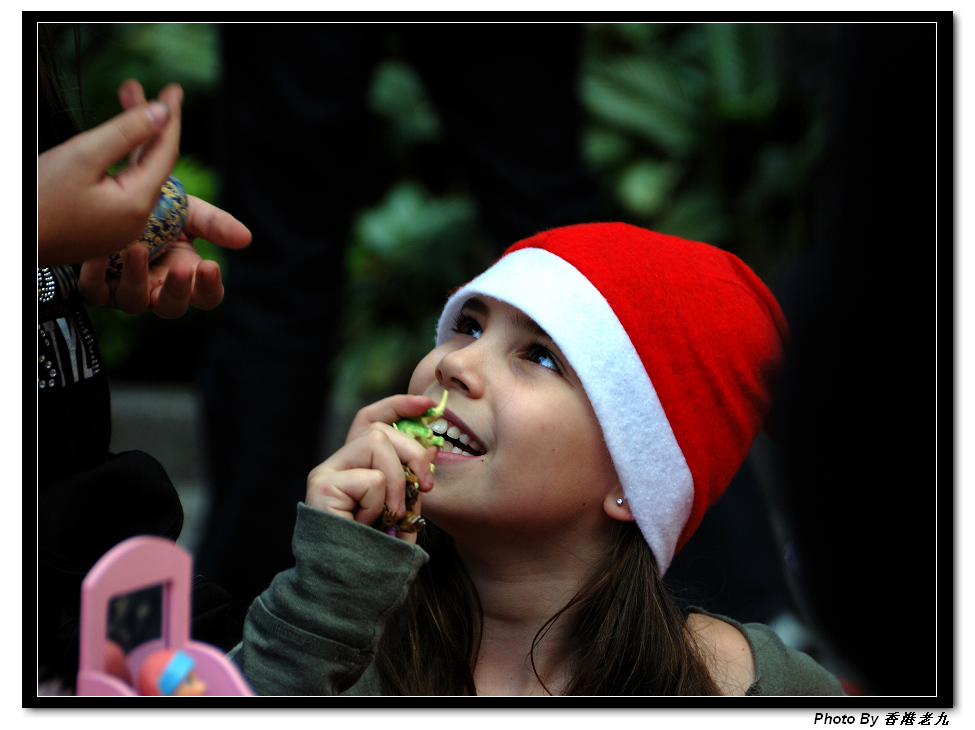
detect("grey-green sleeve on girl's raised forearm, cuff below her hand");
top-left (230, 503), bottom-right (428, 695)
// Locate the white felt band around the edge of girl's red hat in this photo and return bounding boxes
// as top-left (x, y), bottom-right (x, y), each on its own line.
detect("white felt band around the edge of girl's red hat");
top-left (437, 248), bottom-right (694, 575)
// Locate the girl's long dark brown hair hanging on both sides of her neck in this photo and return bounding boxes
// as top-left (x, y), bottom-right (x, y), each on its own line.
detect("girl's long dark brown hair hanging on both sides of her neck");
top-left (376, 522), bottom-right (719, 695)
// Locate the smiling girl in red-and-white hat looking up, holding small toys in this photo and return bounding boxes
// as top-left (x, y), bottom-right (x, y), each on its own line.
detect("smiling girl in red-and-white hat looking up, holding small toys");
top-left (232, 223), bottom-right (842, 695)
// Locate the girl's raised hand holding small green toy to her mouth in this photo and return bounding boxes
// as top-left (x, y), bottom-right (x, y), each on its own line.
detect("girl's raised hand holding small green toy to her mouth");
top-left (305, 395), bottom-right (437, 542)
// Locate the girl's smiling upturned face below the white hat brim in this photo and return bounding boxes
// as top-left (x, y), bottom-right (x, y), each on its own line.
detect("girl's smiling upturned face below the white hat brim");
top-left (410, 297), bottom-right (618, 540)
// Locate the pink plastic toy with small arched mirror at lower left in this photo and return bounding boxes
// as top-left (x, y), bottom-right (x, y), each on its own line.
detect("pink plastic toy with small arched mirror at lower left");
top-left (77, 537), bottom-right (253, 696)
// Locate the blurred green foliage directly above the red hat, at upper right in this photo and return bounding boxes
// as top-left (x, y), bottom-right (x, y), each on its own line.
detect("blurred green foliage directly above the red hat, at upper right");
top-left (582, 23), bottom-right (823, 276)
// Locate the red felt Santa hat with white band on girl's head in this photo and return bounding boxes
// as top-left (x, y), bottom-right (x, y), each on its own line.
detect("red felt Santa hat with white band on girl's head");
top-left (437, 223), bottom-right (788, 575)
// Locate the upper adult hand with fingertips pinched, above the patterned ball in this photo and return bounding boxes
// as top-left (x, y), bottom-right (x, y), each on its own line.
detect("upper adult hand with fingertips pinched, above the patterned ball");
top-left (37, 81), bottom-right (183, 266)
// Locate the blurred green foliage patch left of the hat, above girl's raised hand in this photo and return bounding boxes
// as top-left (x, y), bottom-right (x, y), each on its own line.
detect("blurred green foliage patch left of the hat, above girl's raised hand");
top-left (333, 58), bottom-right (493, 406)
